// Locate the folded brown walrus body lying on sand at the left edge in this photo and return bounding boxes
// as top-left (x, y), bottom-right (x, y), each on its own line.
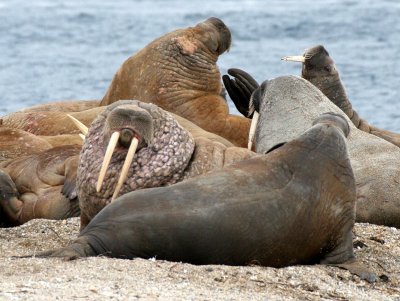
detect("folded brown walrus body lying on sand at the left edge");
top-left (0, 146), bottom-right (80, 227)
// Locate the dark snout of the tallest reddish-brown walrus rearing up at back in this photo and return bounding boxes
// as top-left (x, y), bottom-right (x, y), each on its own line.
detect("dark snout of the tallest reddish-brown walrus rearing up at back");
top-left (197, 17), bottom-right (232, 55)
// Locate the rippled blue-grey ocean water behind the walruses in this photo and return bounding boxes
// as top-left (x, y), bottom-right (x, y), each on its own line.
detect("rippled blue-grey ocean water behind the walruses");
top-left (0, 0), bottom-right (400, 132)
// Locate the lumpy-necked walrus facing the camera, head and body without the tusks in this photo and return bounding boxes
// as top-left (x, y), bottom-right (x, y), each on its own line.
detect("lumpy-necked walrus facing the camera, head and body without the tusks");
top-left (77, 100), bottom-right (255, 228)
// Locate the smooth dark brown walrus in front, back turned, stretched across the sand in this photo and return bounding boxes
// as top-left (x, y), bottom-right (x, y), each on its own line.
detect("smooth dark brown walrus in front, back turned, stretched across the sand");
top-left (30, 114), bottom-right (375, 281)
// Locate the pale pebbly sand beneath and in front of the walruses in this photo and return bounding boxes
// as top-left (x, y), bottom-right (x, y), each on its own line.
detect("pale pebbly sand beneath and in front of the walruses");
top-left (0, 218), bottom-right (400, 300)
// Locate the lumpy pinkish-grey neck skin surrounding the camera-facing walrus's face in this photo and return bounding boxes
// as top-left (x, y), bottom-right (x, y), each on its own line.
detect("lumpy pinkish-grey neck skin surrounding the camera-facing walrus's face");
top-left (77, 101), bottom-right (195, 226)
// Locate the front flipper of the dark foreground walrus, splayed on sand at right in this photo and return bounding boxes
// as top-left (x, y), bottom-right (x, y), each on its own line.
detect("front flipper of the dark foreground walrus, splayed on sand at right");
top-left (321, 227), bottom-right (377, 283)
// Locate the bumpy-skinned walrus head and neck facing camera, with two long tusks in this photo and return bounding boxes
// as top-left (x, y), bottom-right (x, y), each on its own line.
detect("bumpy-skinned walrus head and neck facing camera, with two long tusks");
top-left (77, 100), bottom-right (194, 224)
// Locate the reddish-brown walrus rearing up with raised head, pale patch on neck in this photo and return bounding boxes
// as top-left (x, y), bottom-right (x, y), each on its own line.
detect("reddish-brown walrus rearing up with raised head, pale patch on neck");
top-left (101, 18), bottom-right (250, 146)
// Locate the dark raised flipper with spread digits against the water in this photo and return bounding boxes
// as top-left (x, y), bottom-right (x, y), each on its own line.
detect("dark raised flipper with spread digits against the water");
top-left (222, 68), bottom-right (259, 118)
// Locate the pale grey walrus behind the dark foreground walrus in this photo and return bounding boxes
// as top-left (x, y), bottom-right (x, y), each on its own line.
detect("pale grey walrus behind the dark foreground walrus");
top-left (223, 71), bottom-right (400, 228)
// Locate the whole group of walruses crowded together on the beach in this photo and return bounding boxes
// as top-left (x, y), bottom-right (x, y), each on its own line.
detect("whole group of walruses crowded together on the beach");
top-left (0, 17), bottom-right (400, 282)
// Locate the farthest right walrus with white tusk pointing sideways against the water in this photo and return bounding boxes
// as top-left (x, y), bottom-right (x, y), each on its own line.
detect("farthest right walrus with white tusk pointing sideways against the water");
top-left (282, 45), bottom-right (400, 146)
